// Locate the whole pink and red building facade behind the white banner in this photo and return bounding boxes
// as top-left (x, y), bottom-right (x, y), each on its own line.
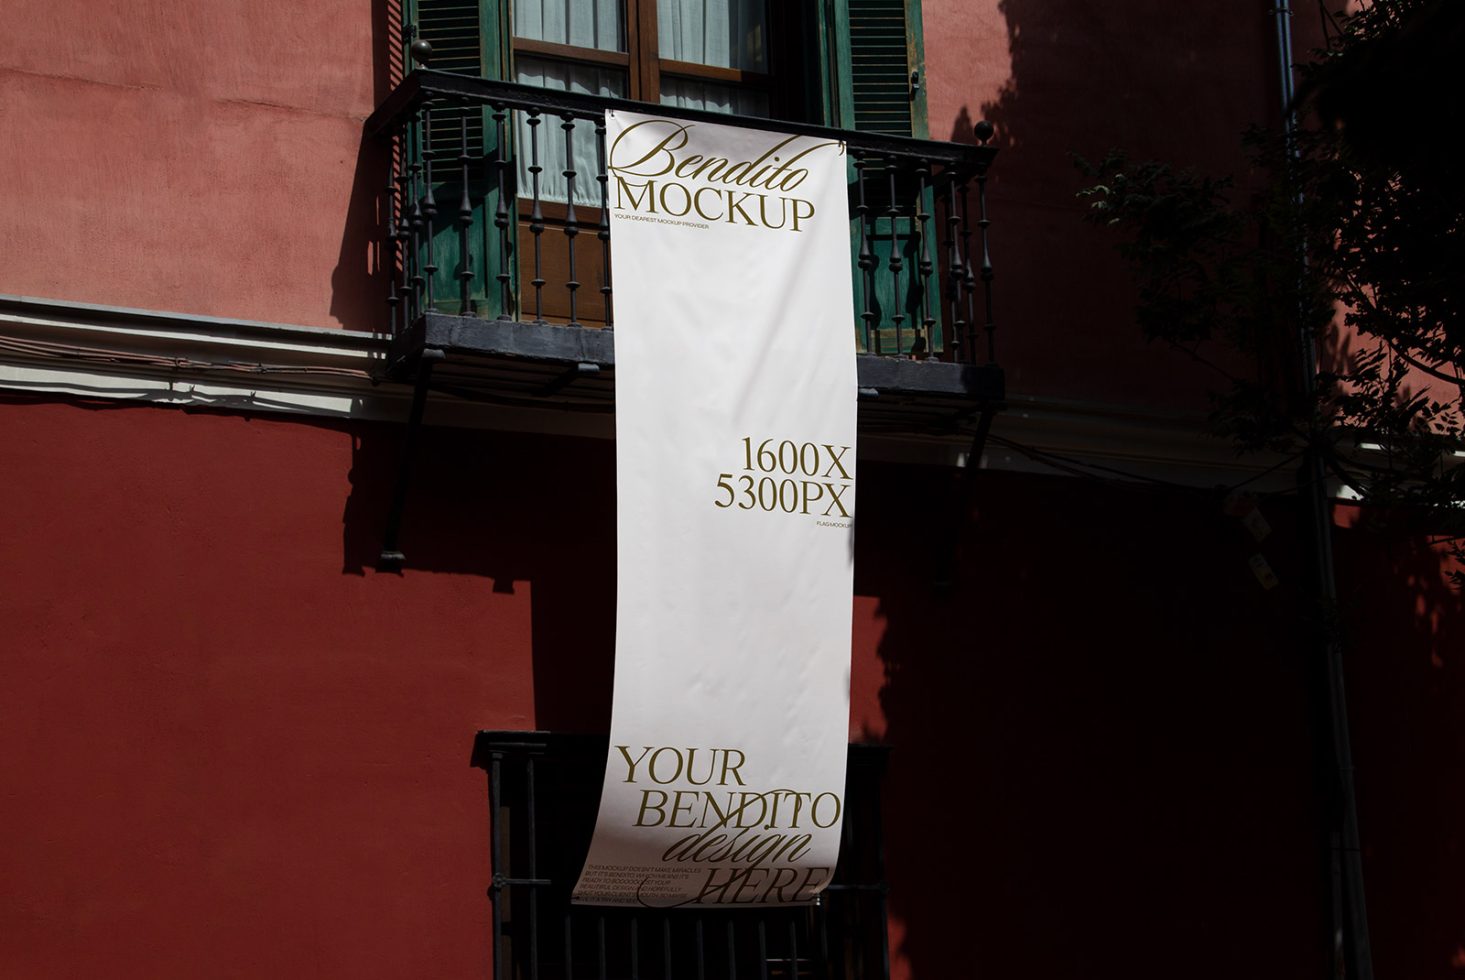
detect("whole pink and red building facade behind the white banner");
top-left (0, 0), bottom-right (1465, 980)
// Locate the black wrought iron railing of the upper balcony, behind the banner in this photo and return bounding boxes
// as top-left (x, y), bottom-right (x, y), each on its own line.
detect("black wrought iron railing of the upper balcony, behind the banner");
top-left (368, 69), bottom-right (996, 365)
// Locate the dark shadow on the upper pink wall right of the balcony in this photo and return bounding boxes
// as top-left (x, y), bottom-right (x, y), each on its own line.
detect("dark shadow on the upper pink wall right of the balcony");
top-left (926, 0), bottom-right (1276, 409)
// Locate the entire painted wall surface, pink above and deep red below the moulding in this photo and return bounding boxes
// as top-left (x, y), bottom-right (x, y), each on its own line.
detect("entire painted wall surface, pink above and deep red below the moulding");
top-left (0, 0), bottom-right (1465, 980)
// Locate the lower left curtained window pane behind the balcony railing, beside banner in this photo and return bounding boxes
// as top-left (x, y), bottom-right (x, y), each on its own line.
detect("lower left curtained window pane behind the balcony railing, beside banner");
top-left (514, 54), bottom-right (626, 207)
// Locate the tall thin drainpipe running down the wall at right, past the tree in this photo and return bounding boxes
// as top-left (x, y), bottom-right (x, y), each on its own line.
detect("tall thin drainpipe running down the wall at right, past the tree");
top-left (1272, 0), bottom-right (1373, 980)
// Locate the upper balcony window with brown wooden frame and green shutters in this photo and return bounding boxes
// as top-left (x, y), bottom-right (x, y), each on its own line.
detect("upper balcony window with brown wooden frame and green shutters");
top-left (404, 0), bottom-right (939, 339)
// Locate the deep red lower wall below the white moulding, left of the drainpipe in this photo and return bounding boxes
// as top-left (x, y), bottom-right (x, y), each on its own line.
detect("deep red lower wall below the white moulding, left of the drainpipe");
top-left (0, 401), bottom-right (1341, 980)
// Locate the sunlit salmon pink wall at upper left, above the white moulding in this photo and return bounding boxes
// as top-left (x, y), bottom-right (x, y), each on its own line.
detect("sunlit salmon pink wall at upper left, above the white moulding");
top-left (0, 0), bottom-right (387, 330)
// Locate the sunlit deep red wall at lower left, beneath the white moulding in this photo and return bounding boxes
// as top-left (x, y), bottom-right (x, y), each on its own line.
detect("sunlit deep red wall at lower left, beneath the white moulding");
top-left (0, 404), bottom-right (533, 977)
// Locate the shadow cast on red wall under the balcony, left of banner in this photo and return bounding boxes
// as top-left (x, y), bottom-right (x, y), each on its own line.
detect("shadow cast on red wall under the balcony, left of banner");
top-left (343, 425), bottom-right (615, 732)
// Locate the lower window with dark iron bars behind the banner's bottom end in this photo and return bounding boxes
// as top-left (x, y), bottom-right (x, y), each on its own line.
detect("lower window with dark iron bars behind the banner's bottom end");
top-left (473, 731), bottom-right (889, 980)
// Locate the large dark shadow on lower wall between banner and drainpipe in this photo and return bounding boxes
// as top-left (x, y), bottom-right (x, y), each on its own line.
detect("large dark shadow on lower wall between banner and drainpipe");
top-left (857, 466), bottom-right (1326, 980)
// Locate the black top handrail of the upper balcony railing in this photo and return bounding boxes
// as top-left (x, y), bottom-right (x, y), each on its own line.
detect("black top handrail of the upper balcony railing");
top-left (366, 67), bottom-right (998, 179)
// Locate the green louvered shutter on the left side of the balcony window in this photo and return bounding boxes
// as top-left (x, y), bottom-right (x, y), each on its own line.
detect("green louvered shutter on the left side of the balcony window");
top-left (403, 0), bottom-right (517, 316)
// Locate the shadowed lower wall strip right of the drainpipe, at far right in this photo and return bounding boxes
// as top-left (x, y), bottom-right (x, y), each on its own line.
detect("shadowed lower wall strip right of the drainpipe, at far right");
top-left (1333, 521), bottom-right (1465, 980)
